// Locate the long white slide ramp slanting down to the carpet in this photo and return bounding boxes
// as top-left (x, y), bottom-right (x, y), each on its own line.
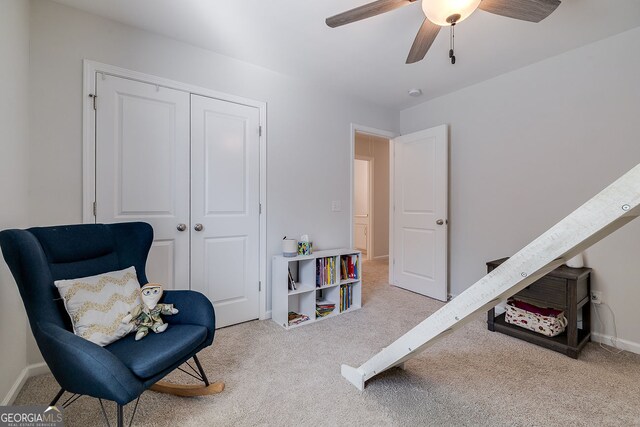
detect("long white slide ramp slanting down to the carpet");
top-left (342, 165), bottom-right (640, 390)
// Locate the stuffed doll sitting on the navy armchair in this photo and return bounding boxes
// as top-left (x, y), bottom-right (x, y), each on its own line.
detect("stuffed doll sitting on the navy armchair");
top-left (122, 283), bottom-right (178, 341)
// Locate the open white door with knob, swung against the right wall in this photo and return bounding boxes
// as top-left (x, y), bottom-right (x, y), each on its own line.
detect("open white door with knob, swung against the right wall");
top-left (391, 125), bottom-right (449, 301)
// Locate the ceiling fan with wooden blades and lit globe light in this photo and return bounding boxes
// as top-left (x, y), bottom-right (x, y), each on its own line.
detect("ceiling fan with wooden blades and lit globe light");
top-left (326, 0), bottom-right (560, 64)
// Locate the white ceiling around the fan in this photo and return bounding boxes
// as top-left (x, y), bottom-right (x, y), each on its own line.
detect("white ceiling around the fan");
top-left (55, 0), bottom-right (640, 109)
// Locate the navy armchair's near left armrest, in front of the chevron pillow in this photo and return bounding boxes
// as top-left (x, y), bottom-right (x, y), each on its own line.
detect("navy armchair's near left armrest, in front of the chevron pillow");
top-left (37, 323), bottom-right (144, 405)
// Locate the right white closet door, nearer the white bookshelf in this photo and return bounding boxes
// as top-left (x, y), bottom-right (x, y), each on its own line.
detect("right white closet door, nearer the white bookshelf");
top-left (191, 95), bottom-right (260, 327)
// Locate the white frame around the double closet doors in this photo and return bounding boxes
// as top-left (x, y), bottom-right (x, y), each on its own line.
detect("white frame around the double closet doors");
top-left (82, 59), bottom-right (268, 320)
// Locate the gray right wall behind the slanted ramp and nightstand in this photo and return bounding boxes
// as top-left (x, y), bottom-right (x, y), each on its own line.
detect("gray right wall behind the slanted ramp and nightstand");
top-left (400, 25), bottom-right (640, 352)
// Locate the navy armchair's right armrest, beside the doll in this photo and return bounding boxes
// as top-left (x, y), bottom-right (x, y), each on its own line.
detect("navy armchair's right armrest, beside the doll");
top-left (161, 291), bottom-right (216, 345)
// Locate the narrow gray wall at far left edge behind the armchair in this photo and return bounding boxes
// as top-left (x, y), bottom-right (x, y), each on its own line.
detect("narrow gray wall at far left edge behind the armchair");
top-left (0, 0), bottom-right (29, 401)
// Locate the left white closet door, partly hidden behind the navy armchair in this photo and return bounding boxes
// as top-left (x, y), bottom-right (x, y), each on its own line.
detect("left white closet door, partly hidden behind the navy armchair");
top-left (96, 75), bottom-right (189, 289)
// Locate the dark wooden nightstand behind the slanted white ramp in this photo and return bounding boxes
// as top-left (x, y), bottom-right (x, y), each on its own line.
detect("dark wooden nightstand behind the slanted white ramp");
top-left (487, 258), bottom-right (591, 359)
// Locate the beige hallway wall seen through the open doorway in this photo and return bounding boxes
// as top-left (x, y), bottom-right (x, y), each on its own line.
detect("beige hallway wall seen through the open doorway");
top-left (355, 133), bottom-right (389, 258)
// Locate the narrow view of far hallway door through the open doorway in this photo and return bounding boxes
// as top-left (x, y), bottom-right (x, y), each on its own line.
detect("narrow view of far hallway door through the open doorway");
top-left (353, 159), bottom-right (371, 259)
